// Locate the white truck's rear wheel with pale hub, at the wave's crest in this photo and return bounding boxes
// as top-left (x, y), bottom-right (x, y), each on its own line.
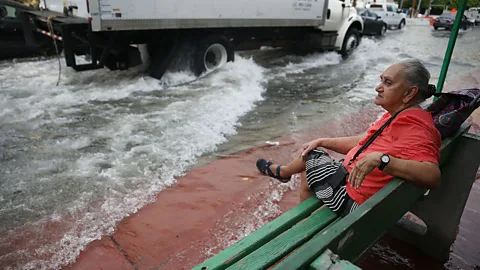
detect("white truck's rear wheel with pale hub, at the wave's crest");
top-left (192, 35), bottom-right (235, 76)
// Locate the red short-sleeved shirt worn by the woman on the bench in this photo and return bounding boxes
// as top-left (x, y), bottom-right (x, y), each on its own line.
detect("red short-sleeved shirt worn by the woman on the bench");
top-left (343, 109), bottom-right (441, 203)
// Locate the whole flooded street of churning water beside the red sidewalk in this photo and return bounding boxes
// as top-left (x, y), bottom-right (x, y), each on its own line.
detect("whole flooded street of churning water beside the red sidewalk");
top-left (0, 26), bottom-right (480, 269)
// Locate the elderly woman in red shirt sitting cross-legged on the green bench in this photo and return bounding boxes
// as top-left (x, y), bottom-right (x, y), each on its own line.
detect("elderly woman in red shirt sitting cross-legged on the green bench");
top-left (257, 59), bottom-right (441, 215)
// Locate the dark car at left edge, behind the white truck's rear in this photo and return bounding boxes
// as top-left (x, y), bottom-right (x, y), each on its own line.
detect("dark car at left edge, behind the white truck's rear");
top-left (0, 0), bottom-right (55, 60)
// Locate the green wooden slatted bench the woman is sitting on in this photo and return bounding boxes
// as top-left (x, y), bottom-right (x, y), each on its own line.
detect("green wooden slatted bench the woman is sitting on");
top-left (194, 124), bottom-right (480, 270)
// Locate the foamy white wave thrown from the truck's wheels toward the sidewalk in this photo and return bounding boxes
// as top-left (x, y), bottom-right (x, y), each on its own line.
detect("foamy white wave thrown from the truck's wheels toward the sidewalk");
top-left (0, 57), bottom-right (266, 269)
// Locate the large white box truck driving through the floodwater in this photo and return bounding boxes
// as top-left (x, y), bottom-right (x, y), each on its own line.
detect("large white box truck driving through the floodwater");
top-left (19, 0), bottom-right (363, 79)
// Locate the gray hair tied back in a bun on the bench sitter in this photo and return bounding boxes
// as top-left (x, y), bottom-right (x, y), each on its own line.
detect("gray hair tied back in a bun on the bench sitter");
top-left (399, 59), bottom-right (435, 102)
